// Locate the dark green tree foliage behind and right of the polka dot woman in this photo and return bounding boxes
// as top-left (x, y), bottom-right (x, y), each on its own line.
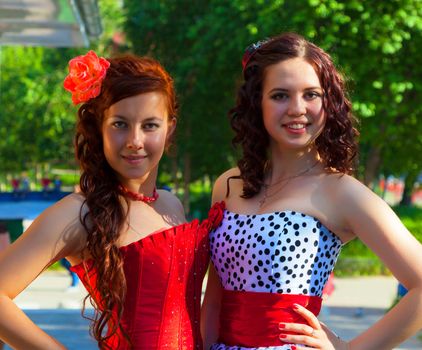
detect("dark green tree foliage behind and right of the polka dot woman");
top-left (124, 0), bottom-right (422, 211)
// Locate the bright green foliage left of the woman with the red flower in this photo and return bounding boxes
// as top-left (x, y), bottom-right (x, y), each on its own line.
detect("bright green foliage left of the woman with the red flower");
top-left (0, 0), bottom-right (123, 173)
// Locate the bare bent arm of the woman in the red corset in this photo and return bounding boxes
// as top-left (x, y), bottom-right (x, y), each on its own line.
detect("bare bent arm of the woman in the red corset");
top-left (0, 195), bottom-right (83, 350)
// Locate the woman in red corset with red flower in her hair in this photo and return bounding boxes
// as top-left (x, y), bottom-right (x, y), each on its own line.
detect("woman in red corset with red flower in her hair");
top-left (0, 51), bottom-right (221, 350)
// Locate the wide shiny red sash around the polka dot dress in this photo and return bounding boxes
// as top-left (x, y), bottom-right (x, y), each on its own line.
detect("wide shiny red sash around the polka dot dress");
top-left (218, 290), bottom-right (322, 347)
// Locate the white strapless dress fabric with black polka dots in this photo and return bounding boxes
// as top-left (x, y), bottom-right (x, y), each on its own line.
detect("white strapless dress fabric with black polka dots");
top-left (210, 210), bottom-right (342, 350)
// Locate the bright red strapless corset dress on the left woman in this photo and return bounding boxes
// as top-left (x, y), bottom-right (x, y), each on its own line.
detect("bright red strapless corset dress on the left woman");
top-left (72, 207), bottom-right (226, 350)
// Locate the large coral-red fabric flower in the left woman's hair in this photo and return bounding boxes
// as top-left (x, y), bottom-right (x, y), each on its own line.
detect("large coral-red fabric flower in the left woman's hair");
top-left (63, 51), bottom-right (110, 105)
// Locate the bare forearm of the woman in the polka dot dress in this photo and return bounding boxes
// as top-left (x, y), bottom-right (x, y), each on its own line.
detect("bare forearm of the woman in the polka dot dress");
top-left (350, 287), bottom-right (422, 350)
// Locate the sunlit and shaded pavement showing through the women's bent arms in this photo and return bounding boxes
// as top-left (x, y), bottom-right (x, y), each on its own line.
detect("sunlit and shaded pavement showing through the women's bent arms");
top-left (5, 271), bottom-right (422, 350)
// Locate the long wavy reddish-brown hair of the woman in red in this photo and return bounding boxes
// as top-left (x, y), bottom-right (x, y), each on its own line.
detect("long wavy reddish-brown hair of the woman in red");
top-left (75, 55), bottom-right (177, 349)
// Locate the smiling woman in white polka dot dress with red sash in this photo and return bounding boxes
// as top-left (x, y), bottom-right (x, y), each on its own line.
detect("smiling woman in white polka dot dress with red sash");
top-left (202, 34), bottom-right (422, 350)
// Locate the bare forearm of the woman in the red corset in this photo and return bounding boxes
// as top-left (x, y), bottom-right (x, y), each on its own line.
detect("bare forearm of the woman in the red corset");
top-left (0, 295), bottom-right (65, 350)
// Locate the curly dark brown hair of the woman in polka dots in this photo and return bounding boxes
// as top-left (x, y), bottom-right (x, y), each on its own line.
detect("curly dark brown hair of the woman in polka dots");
top-left (229, 33), bottom-right (359, 198)
